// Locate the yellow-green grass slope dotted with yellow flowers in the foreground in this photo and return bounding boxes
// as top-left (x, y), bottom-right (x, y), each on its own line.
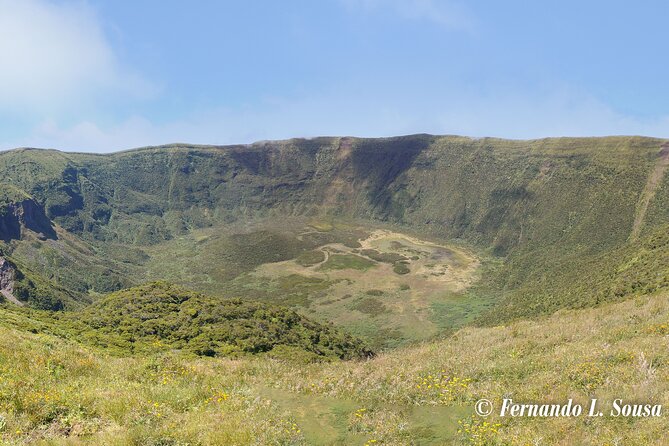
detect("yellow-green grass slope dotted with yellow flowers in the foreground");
top-left (0, 293), bottom-right (669, 445)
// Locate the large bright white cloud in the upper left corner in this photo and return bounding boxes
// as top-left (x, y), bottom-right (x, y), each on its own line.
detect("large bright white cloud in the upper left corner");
top-left (0, 0), bottom-right (155, 115)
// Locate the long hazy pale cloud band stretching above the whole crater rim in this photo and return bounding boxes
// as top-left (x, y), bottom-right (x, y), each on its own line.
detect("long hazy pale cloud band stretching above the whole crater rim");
top-left (6, 83), bottom-right (669, 152)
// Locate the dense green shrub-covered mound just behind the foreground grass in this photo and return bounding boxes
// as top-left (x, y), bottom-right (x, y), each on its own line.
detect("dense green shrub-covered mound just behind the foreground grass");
top-left (29, 282), bottom-right (370, 360)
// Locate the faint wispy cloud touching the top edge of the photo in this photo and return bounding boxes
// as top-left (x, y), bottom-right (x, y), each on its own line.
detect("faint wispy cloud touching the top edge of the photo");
top-left (342, 0), bottom-right (475, 31)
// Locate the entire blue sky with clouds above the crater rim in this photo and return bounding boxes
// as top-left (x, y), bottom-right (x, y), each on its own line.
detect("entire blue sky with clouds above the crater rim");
top-left (0, 0), bottom-right (669, 152)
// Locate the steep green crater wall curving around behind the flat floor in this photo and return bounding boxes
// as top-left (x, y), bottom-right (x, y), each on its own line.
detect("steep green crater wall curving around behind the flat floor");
top-left (0, 135), bottom-right (669, 320)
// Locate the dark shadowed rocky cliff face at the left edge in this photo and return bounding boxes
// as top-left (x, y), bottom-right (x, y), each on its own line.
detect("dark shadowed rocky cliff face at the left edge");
top-left (0, 199), bottom-right (57, 242)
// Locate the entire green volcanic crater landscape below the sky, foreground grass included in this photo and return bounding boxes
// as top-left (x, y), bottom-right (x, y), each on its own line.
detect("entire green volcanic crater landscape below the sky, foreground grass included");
top-left (0, 135), bottom-right (669, 446)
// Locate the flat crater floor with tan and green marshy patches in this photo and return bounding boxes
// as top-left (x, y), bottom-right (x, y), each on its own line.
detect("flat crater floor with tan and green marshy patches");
top-left (147, 219), bottom-right (492, 348)
